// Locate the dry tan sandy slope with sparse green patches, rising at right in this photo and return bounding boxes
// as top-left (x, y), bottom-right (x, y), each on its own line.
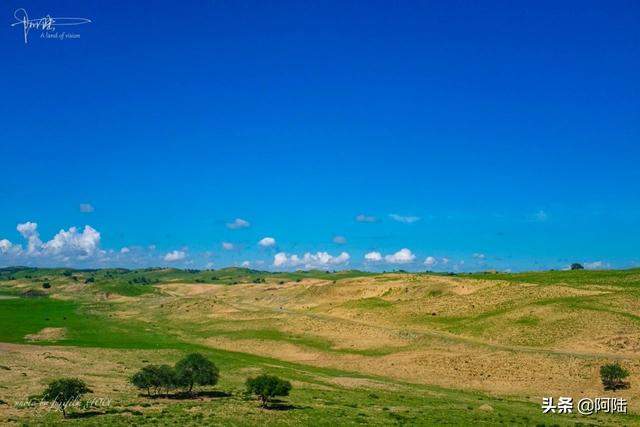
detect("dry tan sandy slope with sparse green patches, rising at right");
top-left (146, 274), bottom-right (640, 409)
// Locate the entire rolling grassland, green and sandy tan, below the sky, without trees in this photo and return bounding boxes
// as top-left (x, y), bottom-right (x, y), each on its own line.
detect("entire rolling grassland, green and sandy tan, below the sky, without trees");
top-left (0, 268), bottom-right (640, 425)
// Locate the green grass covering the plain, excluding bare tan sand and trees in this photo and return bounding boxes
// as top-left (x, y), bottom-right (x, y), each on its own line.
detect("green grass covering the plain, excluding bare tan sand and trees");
top-left (0, 269), bottom-right (640, 426)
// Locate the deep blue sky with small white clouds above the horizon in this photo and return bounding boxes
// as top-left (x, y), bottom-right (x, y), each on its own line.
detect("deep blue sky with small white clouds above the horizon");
top-left (0, 0), bottom-right (640, 271)
